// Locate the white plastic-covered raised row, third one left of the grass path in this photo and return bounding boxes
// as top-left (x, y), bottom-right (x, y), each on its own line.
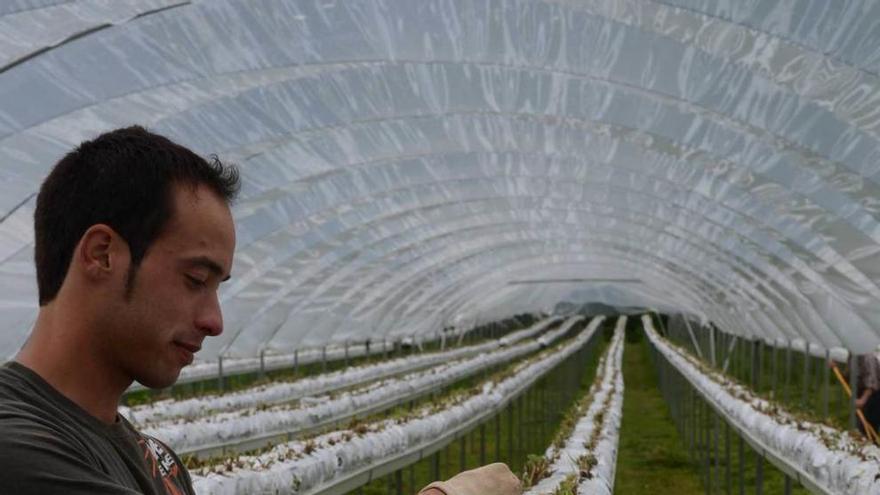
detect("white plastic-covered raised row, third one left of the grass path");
top-left (154, 316), bottom-right (584, 459)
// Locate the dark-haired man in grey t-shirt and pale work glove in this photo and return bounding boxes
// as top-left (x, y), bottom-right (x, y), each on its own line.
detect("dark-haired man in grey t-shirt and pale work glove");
top-left (0, 127), bottom-right (514, 495)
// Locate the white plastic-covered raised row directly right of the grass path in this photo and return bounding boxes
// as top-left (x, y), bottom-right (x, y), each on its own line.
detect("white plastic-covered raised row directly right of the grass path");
top-left (642, 315), bottom-right (880, 495)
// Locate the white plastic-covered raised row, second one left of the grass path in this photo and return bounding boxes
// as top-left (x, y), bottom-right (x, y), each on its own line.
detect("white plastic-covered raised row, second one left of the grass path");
top-left (193, 317), bottom-right (602, 495)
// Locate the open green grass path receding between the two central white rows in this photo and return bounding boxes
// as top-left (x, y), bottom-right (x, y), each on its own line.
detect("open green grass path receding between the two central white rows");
top-left (614, 335), bottom-right (703, 495)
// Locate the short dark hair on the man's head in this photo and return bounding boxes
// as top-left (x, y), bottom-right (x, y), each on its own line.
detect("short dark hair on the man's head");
top-left (34, 126), bottom-right (239, 306)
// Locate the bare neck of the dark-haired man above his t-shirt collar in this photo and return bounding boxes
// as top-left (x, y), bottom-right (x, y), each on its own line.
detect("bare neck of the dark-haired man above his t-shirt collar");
top-left (15, 308), bottom-right (131, 423)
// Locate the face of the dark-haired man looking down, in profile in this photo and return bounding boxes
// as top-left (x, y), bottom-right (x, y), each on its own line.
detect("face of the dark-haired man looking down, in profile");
top-left (104, 186), bottom-right (235, 388)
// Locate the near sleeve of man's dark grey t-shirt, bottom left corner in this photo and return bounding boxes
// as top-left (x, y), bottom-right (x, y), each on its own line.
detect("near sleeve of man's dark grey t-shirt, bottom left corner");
top-left (0, 420), bottom-right (139, 495)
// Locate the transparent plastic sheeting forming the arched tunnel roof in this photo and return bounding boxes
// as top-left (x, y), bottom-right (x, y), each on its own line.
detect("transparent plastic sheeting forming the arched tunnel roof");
top-left (0, 0), bottom-right (880, 358)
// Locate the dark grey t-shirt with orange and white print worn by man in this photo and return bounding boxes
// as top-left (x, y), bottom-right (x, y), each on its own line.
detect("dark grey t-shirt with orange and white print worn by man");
top-left (0, 362), bottom-right (194, 495)
